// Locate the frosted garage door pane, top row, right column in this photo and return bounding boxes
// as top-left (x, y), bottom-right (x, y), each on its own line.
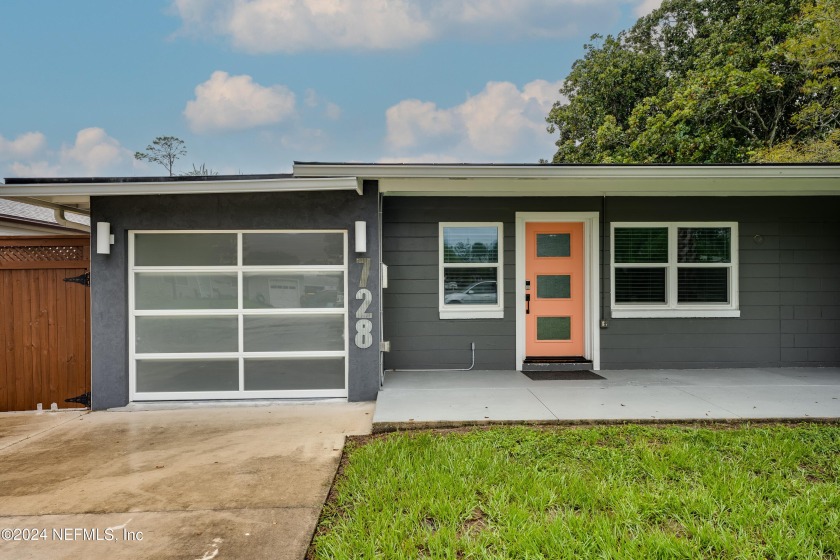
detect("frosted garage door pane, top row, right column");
top-left (242, 232), bottom-right (344, 266)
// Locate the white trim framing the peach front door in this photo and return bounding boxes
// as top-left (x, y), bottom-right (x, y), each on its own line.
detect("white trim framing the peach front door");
top-left (514, 212), bottom-right (601, 370)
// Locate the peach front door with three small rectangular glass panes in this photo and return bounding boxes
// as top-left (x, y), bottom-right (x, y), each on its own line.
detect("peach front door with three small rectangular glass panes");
top-left (525, 222), bottom-right (586, 358)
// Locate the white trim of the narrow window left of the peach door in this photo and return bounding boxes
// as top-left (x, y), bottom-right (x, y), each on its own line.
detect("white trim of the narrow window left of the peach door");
top-left (438, 222), bottom-right (505, 319)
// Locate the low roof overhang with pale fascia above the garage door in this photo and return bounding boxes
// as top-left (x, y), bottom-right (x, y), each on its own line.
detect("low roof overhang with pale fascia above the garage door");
top-left (0, 177), bottom-right (362, 209)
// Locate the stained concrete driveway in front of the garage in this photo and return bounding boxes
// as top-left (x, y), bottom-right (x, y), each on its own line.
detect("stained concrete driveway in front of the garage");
top-left (0, 403), bottom-right (373, 560)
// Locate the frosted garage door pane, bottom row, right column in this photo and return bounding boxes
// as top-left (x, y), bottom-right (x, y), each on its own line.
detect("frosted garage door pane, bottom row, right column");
top-left (245, 358), bottom-right (344, 391)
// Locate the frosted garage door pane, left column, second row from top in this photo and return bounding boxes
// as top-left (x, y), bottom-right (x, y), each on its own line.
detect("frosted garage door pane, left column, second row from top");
top-left (134, 272), bottom-right (238, 310)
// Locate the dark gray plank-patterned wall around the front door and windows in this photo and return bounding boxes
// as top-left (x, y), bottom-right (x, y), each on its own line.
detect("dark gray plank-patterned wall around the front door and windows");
top-left (383, 197), bottom-right (840, 369)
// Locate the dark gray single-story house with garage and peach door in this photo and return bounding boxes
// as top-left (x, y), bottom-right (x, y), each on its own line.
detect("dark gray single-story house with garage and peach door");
top-left (0, 162), bottom-right (840, 409)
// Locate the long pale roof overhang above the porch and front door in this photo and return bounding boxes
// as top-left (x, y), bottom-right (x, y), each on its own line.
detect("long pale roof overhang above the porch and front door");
top-left (294, 163), bottom-right (840, 196)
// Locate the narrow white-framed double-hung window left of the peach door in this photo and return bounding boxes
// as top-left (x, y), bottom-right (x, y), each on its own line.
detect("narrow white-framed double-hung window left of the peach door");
top-left (438, 222), bottom-right (504, 319)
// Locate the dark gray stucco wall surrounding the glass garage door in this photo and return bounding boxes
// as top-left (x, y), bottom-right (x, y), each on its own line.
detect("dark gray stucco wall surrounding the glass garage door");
top-left (91, 183), bottom-right (381, 409)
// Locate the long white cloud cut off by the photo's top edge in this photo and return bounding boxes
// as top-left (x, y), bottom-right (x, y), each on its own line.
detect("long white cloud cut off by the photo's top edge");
top-left (173, 0), bottom-right (639, 53)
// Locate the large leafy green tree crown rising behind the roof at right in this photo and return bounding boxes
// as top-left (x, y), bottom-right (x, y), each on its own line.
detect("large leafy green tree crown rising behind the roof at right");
top-left (547, 0), bottom-right (840, 163)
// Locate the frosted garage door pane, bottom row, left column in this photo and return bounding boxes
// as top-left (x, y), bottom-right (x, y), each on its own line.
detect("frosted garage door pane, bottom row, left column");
top-left (137, 360), bottom-right (239, 393)
